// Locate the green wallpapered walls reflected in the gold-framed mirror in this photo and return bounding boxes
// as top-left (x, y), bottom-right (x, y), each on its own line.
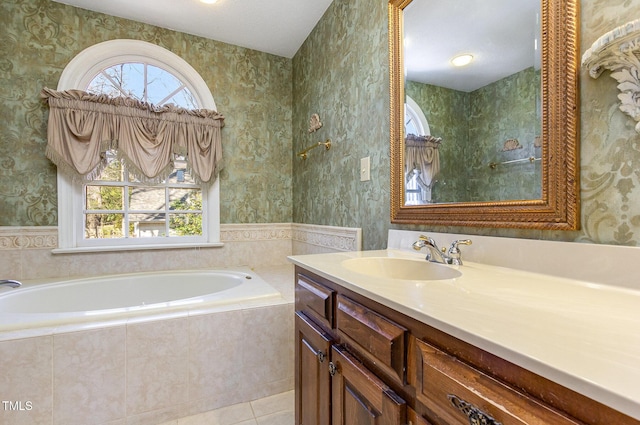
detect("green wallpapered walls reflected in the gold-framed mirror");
top-left (405, 68), bottom-right (542, 202)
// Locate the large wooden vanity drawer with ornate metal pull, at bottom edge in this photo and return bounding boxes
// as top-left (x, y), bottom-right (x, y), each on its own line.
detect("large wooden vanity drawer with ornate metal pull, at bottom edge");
top-left (409, 339), bottom-right (579, 425)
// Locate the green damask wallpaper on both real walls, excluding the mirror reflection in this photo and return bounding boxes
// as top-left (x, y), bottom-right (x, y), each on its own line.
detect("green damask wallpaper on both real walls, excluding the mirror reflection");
top-left (0, 0), bottom-right (640, 249)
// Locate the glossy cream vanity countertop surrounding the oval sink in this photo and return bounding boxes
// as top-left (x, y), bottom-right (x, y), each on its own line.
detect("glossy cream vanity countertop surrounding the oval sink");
top-left (289, 249), bottom-right (640, 419)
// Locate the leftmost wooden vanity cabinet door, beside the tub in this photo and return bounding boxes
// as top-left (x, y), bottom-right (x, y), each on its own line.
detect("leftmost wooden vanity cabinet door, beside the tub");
top-left (295, 312), bottom-right (331, 425)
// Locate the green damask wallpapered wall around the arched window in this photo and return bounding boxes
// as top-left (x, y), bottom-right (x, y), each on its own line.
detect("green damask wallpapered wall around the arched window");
top-left (0, 0), bottom-right (292, 226)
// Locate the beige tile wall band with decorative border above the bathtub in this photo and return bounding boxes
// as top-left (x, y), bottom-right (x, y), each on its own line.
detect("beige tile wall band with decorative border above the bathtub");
top-left (0, 223), bottom-right (362, 280)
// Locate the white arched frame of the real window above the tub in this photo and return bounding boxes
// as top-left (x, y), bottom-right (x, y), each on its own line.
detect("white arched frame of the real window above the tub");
top-left (53, 40), bottom-right (223, 253)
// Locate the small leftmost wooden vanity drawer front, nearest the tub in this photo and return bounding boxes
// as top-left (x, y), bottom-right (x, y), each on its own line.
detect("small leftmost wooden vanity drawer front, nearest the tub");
top-left (296, 274), bottom-right (335, 329)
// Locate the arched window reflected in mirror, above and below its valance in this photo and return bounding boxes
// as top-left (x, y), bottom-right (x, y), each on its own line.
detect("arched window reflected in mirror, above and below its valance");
top-left (404, 96), bottom-right (431, 205)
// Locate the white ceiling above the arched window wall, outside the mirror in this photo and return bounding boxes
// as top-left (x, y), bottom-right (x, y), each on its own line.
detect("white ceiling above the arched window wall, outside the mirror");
top-left (54, 0), bottom-right (332, 58)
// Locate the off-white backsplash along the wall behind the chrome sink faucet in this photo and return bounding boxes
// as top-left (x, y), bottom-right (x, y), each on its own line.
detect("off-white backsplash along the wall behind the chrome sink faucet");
top-left (387, 230), bottom-right (640, 290)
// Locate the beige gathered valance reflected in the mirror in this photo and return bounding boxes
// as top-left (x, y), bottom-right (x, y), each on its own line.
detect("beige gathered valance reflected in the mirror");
top-left (405, 134), bottom-right (442, 186)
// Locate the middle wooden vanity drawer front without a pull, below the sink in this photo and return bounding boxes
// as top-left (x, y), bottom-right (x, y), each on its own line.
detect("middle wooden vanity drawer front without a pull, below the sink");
top-left (336, 295), bottom-right (407, 383)
